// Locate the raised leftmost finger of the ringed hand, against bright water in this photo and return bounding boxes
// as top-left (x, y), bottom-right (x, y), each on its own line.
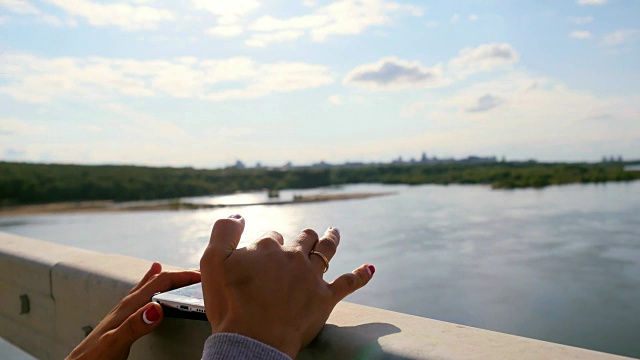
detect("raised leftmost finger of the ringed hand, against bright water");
top-left (200, 215), bottom-right (244, 269)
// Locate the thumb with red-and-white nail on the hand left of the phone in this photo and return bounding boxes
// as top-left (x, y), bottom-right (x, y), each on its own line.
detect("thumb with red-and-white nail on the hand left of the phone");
top-left (108, 303), bottom-right (163, 354)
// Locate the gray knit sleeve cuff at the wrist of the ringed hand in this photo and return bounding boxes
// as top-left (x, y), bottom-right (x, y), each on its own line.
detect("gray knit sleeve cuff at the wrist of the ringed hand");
top-left (202, 333), bottom-right (291, 360)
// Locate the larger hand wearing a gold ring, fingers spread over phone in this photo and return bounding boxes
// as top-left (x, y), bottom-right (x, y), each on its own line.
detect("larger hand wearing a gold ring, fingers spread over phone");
top-left (200, 215), bottom-right (375, 358)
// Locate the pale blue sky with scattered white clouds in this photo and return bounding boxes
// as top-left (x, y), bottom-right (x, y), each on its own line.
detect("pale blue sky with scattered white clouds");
top-left (0, 0), bottom-right (640, 168)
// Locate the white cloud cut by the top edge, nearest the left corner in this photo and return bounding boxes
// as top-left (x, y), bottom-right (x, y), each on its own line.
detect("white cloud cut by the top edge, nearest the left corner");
top-left (46, 0), bottom-right (176, 30)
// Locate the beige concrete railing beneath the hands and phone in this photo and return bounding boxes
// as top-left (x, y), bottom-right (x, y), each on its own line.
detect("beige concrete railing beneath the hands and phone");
top-left (0, 233), bottom-right (622, 360)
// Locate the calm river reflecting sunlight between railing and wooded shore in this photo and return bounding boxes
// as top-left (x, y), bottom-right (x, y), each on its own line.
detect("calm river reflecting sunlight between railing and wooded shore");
top-left (0, 181), bottom-right (640, 357)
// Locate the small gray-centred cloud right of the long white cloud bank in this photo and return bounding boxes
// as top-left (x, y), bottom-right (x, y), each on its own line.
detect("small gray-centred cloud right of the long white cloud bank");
top-left (344, 57), bottom-right (442, 89)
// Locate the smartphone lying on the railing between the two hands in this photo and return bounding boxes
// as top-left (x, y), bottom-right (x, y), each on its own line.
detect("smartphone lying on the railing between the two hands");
top-left (151, 283), bottom-right (207, 321)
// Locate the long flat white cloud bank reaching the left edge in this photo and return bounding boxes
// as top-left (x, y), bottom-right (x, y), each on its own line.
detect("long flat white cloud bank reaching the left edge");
top-left (0, 54), bottom-right (333, 103)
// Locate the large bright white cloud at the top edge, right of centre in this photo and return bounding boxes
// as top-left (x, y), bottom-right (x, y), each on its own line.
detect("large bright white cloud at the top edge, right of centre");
top-left (248, 0), bottom-right (424, 46)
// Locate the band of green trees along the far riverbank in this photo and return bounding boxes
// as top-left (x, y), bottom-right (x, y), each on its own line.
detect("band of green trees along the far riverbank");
top-left (0, 162), bottom-right (640, 205)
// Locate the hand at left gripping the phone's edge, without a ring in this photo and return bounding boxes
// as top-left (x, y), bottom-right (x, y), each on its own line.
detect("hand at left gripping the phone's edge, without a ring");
top-left (67, 262), bottom-right (200, 360)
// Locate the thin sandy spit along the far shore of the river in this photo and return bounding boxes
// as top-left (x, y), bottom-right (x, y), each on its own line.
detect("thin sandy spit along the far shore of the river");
top-left (0, 192), bottom-right (392, 217)
